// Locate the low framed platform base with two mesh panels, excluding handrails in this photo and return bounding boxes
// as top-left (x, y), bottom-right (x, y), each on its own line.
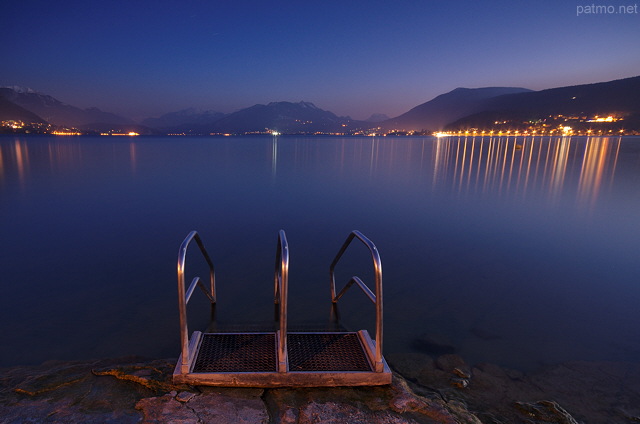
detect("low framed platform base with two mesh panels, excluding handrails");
top-left (173, 330), bottom-right (391, 387)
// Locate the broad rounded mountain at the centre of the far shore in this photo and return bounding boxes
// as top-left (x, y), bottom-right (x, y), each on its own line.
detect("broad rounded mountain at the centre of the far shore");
top-left (207, 102), bottom-right (369, 134)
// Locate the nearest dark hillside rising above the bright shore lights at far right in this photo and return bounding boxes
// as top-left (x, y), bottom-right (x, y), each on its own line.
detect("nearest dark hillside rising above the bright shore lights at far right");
top-left (447, 76), bottom-right (640, 130)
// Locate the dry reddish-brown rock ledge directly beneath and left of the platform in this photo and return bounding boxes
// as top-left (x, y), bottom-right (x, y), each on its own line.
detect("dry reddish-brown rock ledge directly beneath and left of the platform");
top-left (0, 358), bottom-right (480, 424)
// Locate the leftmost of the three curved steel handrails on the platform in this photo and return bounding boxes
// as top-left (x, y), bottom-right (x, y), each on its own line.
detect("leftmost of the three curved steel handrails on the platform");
top-left (178, 231), bottom-right (216, 374)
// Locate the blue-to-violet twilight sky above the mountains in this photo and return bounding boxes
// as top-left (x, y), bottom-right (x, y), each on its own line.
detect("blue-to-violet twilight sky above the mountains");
top-left (0, 0), bottom-right (640, 119)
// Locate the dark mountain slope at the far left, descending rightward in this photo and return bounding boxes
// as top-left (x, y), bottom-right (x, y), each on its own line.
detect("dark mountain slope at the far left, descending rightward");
top-left (0, 87), bottom-right (133, 127)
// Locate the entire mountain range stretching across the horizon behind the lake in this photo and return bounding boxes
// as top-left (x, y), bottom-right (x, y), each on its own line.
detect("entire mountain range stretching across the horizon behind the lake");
top-left (0, 76), bottom-right (640, 134)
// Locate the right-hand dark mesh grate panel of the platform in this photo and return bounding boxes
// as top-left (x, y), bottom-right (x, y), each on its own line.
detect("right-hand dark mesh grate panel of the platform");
top-left (287, 333), bottom-right (372, 371)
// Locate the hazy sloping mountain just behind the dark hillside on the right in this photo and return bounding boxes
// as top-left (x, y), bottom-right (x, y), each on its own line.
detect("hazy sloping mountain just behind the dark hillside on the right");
top-left (380, 87), bottom-right (531, 131)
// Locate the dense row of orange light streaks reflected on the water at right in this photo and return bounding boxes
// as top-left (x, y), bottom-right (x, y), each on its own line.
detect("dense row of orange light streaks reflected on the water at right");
top-left (433, 136), bottom-right (621, 206)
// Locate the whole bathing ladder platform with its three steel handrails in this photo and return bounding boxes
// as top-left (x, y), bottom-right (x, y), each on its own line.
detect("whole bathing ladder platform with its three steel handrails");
top-left (173, 230), bottom-right (391, 387)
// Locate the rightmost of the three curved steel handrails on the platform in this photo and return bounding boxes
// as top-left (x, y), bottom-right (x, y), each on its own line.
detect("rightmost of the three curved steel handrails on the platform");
top-left (329, 230), bottom-right (384, 372)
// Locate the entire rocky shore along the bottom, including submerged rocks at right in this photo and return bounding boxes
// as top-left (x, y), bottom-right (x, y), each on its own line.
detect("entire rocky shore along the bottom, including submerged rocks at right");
top-left (0, 353), bottom-right (640, 424)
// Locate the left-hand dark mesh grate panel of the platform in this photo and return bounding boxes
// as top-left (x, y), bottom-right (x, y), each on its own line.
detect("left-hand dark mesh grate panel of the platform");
top-left (193, 333), bottom-right (277, 373)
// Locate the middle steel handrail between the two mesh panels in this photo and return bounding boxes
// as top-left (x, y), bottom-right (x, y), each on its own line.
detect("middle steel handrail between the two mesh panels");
top-left (273, 230), bottom-right (289, 372)
